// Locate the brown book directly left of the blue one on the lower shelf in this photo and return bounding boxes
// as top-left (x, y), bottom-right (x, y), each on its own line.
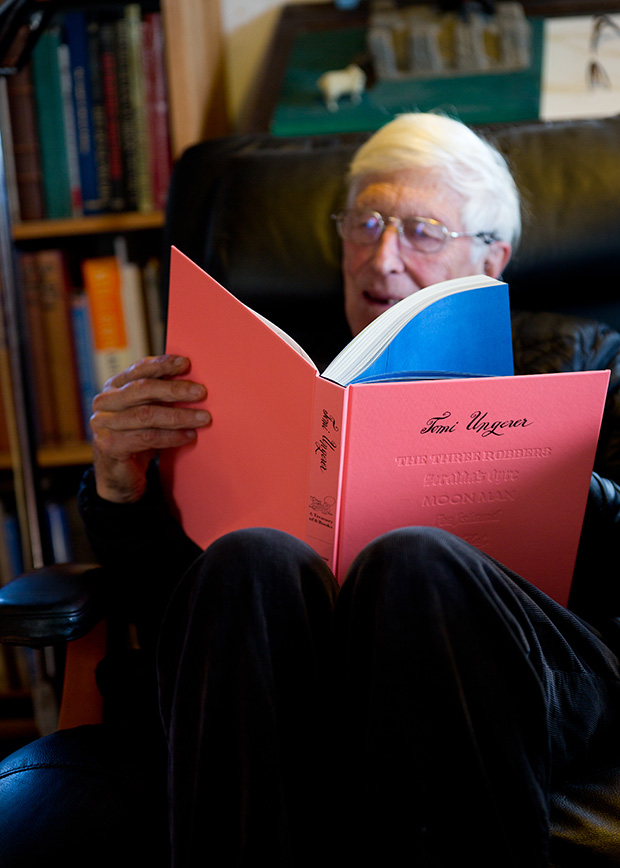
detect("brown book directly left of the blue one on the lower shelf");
top-left (36, 250), bottom-right (83, 443)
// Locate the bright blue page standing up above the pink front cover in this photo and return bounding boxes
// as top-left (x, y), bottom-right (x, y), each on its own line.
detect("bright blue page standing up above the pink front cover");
top-left (351, 284), bottom-right (514, 383)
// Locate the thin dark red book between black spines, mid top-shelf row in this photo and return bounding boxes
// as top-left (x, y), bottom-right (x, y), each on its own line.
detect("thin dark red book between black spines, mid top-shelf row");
top-left (99, 20), bottom-right (128, 211)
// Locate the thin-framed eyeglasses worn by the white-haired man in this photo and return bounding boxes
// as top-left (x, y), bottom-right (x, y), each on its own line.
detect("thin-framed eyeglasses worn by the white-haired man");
top-left (332, 209), bottom-right (499, 253)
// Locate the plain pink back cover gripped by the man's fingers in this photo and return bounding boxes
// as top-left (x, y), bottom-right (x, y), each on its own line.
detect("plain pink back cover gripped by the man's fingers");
top-left (160, 249), bottom-right (324, 547)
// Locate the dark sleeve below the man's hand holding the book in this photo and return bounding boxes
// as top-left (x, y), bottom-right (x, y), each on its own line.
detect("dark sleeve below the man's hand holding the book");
top-left (78, 464), bottom-right (201, 646)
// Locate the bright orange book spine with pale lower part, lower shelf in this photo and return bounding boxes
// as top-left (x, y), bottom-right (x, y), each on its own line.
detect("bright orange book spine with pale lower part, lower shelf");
top-left (82, 256), bottom-right (131, 391)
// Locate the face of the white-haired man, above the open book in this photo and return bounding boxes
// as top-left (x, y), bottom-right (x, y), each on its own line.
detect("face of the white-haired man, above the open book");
top-left (343, 170), bottom-right (504, 335)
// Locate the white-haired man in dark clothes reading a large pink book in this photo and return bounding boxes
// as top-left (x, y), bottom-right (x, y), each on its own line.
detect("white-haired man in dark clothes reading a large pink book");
top-left (81, 114), bottom-right (620, 868)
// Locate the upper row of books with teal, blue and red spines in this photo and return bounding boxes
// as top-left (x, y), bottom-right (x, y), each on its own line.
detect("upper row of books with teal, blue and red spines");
top-left (0, 3), bottom-right (171, 222)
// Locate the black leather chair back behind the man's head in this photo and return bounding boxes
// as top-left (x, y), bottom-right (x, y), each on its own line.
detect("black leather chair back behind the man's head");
top-left (165, 117), bottom-right (620, 366)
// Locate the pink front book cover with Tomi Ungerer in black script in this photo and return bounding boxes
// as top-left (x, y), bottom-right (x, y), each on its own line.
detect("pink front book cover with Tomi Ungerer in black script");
top-left (336, 371), bottom-right (609, 605)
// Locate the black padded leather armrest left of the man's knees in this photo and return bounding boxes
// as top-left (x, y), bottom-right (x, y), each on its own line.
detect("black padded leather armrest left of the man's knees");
top-left (0, 564), bottom-right (105, 648)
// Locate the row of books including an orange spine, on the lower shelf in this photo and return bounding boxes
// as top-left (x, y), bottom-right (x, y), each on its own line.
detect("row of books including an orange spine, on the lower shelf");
top-left (19, 239), bottom-right (164, 446)
